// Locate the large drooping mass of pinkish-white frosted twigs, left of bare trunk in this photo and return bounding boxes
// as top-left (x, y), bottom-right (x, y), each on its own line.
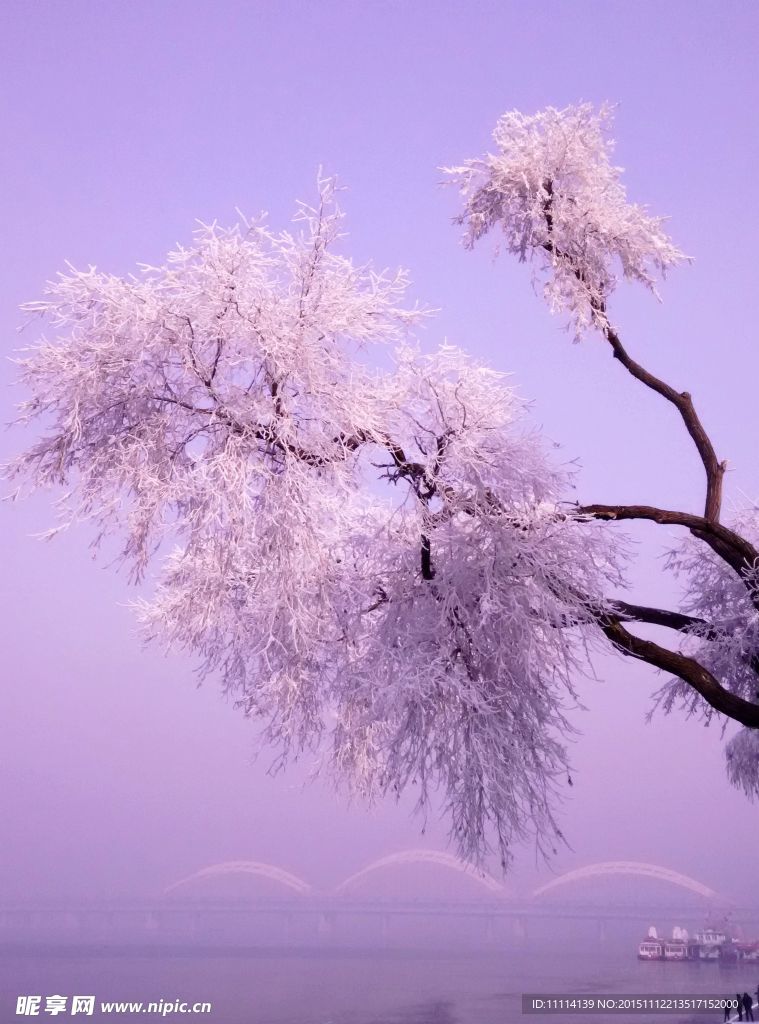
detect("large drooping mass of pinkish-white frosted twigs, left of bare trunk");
top-left (7, 181), bottom-right (620, 860)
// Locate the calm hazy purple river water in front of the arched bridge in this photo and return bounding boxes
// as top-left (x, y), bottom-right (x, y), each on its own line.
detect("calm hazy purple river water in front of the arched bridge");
top-left (0, 948), bottom-right (759, 1024)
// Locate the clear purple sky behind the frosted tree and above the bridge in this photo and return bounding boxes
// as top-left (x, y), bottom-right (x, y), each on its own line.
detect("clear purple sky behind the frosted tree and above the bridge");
top-left (0, 0), bottom-right (759, 898)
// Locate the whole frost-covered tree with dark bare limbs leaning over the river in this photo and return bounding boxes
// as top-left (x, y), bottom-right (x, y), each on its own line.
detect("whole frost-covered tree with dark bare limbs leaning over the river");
top-left (9, 106), bottom-right (759, 862)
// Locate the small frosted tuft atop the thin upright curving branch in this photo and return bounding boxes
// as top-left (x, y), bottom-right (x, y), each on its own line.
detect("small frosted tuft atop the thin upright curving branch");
top-left (446, 103), bottom-right (685, 338)
